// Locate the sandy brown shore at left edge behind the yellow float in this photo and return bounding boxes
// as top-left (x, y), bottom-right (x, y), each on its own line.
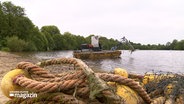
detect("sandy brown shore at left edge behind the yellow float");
top-left (0, 51), bottom-right (38, 104)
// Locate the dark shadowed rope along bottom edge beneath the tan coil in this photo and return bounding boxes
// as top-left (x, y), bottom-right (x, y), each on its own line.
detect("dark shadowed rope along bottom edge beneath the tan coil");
top-left (7, 93), bottom-right (86, 104)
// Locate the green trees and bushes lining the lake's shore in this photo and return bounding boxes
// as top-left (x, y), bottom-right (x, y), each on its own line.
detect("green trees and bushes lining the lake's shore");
top-left (0, 2), bottom-right (184, 51)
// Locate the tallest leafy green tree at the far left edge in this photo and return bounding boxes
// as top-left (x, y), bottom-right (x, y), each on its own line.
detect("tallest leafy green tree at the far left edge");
top-left (0, 2), bottom-right (39, 48)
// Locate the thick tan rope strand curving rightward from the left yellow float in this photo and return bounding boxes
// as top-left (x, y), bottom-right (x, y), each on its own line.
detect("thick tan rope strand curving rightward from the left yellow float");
top-left (13, 76), bottom-right (86, 92)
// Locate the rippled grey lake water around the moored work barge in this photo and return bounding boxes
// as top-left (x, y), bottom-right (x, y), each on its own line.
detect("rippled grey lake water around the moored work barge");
top-left (14, 50), bottom-right (184, 74)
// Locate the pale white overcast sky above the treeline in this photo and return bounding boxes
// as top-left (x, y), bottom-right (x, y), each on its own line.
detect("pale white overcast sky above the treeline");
top-left (1, 0), bottom-right (184, 44)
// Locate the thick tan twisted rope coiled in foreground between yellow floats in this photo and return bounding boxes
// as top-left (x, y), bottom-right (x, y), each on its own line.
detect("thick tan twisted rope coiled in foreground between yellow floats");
top-left (8, 58), bottom-right (151, 104)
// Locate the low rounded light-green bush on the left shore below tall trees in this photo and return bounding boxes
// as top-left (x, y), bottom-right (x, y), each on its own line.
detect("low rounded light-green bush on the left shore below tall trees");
top-left (7, 36), bottom-right (27, 52)
